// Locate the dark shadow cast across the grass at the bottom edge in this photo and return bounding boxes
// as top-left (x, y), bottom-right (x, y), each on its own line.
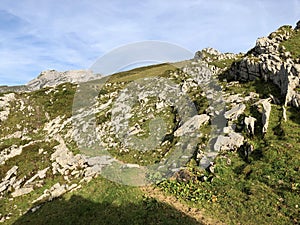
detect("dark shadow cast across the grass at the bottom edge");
top-left (14, 195), bottom-right (201, 225)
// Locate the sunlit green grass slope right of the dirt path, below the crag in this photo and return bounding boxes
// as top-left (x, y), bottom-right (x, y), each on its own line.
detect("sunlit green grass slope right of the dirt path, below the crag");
top-left (160, 82), bottom-right (300, 224)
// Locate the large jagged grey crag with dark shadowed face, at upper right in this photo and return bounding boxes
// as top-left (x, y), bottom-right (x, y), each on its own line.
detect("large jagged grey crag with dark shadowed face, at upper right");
top-left (225, 26), bottom-right (300, 107)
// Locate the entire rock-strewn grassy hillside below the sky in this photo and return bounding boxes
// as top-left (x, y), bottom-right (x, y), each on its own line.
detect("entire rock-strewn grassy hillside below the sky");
top-left (0, 22), bottom-right (300, 224)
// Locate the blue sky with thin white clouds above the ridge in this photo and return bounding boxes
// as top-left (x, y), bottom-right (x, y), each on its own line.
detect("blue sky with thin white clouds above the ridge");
top-left (0, 0), bottom-right (300, 85)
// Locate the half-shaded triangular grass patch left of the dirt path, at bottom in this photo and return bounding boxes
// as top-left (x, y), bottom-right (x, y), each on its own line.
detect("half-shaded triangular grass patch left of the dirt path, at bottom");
top-left (13, 178), bottom-right (204, 225)
